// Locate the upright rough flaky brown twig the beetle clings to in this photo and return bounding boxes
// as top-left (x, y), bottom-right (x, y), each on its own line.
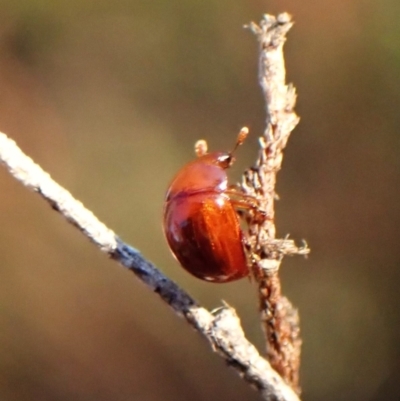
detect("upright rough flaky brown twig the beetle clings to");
top-left (242, 13), bottom-right (309, 393)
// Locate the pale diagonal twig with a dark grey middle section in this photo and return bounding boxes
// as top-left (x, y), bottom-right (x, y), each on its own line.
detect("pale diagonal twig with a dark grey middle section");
top-left (0, 128), bottom-right (299, 401)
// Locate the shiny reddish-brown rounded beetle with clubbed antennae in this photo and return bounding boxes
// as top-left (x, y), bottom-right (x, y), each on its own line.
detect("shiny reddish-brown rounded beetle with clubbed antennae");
top-left (163, 127), bottom-right (257, 283)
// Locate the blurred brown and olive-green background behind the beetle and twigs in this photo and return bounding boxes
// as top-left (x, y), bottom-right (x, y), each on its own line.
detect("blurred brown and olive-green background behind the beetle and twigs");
top-left (0, 0), bottom-right (400, 401)
